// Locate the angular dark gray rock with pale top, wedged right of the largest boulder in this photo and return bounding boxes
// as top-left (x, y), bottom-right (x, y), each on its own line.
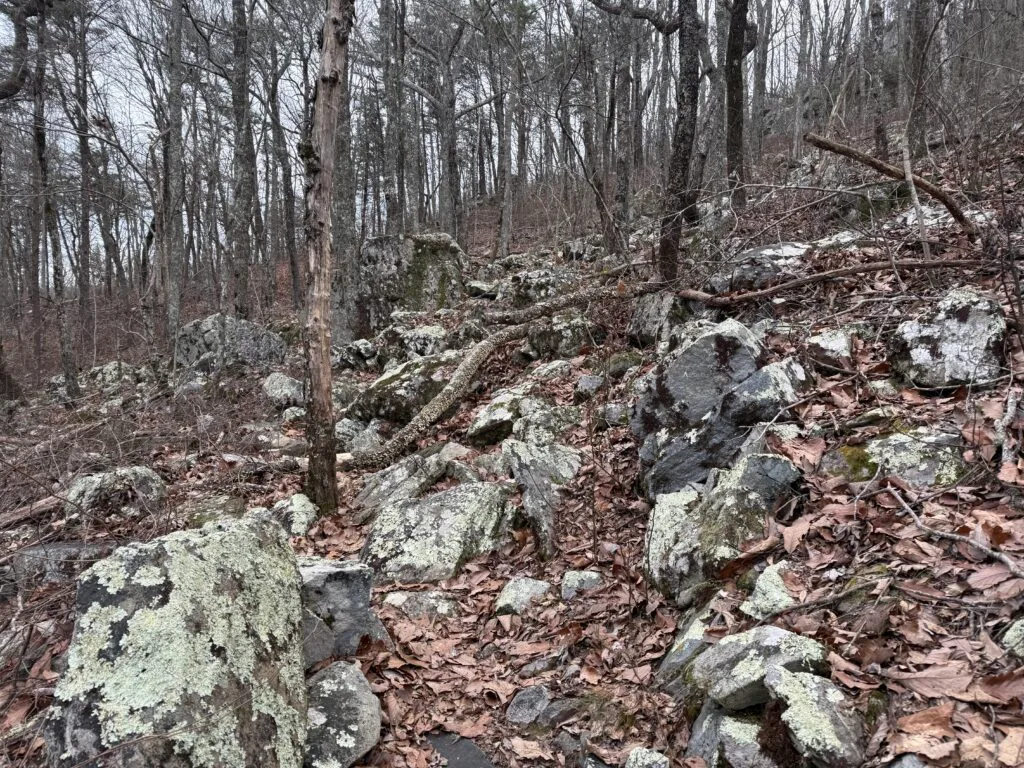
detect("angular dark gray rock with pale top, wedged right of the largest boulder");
top-left (299, 557), bottom-right (386, 667)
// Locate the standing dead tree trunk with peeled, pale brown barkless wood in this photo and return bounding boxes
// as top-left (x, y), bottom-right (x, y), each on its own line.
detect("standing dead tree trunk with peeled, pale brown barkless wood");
top-left (305, 0), bottom-right (355, 515)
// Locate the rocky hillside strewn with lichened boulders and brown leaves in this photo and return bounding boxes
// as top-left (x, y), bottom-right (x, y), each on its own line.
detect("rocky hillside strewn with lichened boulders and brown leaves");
top-left (0, 195), bottom-right (1024, 768)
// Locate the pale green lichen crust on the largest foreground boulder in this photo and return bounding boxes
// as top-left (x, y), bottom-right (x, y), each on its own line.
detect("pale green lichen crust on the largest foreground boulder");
top-left (55, 520), bottom-right (305, 766)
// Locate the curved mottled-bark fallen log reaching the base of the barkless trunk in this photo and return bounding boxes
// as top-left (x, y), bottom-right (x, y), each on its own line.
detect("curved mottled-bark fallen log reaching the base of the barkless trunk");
top-left (338, 323), bottom-right (534, 470)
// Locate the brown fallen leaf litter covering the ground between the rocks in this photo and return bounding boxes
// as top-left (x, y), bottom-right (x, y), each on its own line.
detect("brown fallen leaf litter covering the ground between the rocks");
top-left (0, 141), bottom-right (1024, 768)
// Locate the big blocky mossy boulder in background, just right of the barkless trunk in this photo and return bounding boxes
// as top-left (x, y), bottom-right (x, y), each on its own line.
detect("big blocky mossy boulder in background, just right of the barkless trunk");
top-left (349, 232), bottom-right (465, 338)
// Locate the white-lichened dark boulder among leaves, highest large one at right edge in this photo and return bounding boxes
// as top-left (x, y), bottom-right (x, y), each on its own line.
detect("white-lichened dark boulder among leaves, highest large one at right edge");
top-left (890, 289), bottom-right (1007, 388)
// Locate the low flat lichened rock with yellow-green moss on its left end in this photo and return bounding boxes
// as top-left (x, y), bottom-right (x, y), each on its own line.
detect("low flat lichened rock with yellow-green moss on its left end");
top-left (821, 427), bottom-right (967, 487)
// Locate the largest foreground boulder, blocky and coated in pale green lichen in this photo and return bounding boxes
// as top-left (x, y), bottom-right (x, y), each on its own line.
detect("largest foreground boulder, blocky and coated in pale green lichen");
top-left (45, 518), bottom-right (306, 768)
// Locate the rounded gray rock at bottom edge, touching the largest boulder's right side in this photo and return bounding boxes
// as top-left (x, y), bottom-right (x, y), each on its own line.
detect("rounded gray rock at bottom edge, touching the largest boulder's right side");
top-left (305, 662), bottom-right (381, 768)
